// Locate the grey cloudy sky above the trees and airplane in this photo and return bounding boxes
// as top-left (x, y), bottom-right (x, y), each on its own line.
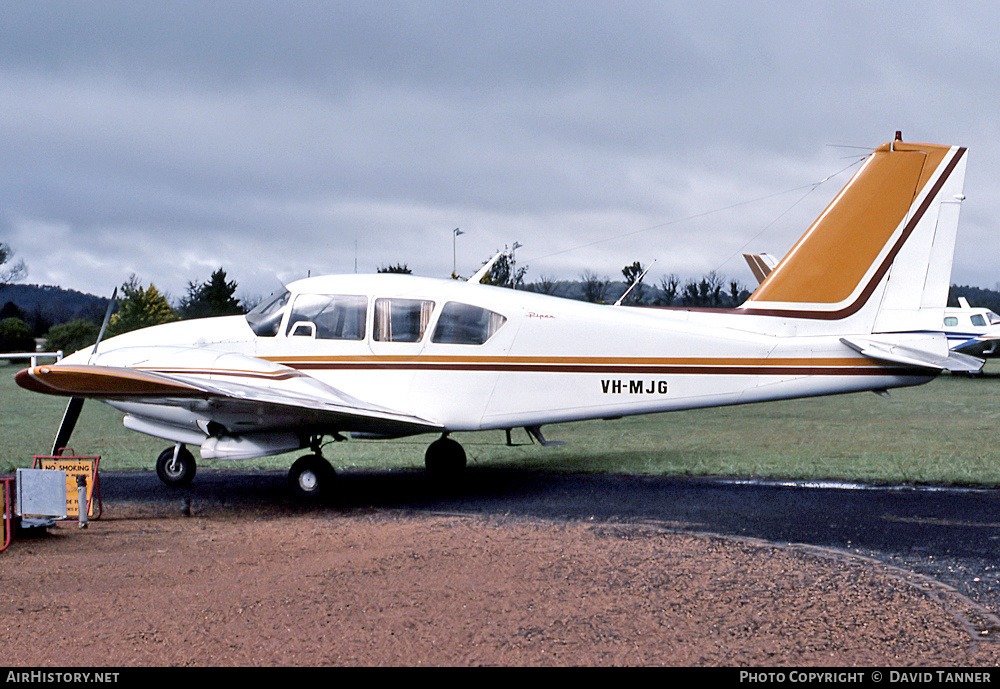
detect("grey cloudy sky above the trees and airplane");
top-left (0, 0), bottom-right (1000, 298)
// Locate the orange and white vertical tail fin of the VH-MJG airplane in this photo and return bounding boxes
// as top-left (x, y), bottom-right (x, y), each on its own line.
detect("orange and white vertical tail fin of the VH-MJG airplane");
top-left (741, 139), bottom-right (966, 333)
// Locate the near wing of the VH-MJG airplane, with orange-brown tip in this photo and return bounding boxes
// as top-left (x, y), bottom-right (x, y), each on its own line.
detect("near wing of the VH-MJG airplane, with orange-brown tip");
top-left (16, 350), bottom-right (441, 435)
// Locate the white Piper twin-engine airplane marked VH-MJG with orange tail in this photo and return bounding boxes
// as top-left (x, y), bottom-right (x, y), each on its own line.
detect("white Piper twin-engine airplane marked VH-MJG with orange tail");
top-left (17, 135), bottom-right (983, 495)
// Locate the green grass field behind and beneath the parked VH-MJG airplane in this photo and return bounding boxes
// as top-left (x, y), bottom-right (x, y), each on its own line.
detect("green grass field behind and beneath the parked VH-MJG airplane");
top-left (0, 362), bottom-right (1000, 486)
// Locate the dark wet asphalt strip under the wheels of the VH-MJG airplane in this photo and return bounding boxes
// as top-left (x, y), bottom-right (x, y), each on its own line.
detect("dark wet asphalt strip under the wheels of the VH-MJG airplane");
top-left (95, 467), bottom-right (1000, 615)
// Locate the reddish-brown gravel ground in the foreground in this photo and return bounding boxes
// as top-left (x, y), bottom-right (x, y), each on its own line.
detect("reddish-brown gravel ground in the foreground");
top-left (0, 503), bottom-right (1000, 667)
